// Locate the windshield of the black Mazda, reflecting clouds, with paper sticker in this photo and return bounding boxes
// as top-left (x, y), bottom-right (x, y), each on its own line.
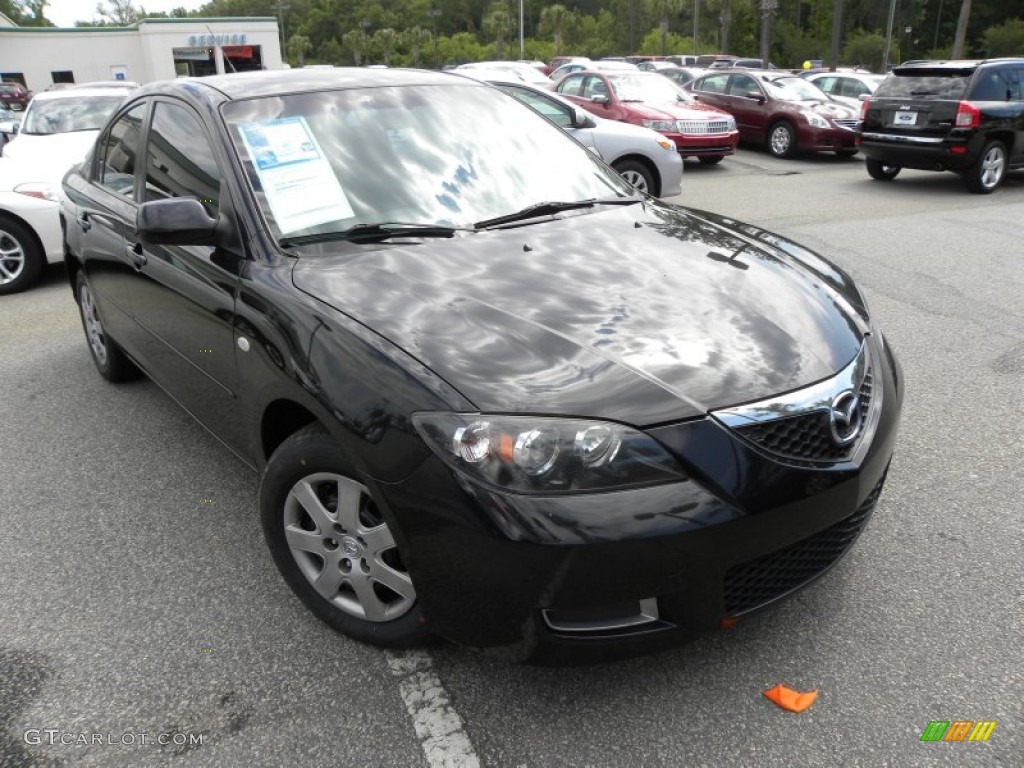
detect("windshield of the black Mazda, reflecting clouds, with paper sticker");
top-left (223, 84), bottom-right (634, 239)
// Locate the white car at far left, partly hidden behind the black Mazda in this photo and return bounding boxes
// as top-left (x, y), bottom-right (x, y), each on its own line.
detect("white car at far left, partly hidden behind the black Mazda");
top-left (0, 86), bottom-right (130, 295)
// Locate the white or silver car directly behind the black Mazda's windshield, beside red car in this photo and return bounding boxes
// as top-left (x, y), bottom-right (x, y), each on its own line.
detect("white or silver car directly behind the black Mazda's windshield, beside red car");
top-left (483, 78), bottom-right (683, 198)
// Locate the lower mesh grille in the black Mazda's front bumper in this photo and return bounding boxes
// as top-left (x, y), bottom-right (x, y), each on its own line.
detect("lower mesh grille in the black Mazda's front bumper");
top-left (724, 475), bottom-right (885, 615)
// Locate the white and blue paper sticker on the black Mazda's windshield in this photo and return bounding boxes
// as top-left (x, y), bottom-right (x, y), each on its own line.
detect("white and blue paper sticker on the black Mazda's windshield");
top-left (239, 118), bottom-right (355, 234)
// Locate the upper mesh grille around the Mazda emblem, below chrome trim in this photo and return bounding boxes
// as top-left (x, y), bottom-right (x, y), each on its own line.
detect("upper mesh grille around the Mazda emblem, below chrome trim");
top-left (736, 368), bottom-right (871, 462)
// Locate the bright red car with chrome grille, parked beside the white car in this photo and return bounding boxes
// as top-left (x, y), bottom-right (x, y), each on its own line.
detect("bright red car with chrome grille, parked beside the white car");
top-left (555, 71), bottom-right (739, 165)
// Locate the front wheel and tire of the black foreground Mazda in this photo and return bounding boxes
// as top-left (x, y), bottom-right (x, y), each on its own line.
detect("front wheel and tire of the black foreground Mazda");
top-left (259, 424), bottom-right (427, 647)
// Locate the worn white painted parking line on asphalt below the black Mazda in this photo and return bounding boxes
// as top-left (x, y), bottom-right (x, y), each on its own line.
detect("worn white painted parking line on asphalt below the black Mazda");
top-left (385, 650), bottom-right (480, 768)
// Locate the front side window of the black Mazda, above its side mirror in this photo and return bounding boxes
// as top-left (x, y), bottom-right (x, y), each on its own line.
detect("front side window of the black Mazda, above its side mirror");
top-left (145, 101), bottom-right (221, 217)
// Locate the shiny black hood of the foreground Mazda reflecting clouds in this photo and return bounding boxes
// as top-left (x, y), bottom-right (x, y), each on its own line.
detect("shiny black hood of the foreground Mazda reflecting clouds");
top-left (293, 202), bottom-right (865, 426)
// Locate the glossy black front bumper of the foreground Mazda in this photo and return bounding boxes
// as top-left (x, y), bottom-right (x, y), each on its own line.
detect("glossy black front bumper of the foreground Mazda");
top-left (379, 333), bottom-right (902, 657)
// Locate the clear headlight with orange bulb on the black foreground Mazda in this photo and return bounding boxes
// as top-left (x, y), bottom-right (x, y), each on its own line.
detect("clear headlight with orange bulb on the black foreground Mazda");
top-left (413, 413), bottom-right (686, 494)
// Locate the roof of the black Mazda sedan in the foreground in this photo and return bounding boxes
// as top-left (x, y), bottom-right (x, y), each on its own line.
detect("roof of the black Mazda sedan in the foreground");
top-left (136, 67), bottom-right (470, 99)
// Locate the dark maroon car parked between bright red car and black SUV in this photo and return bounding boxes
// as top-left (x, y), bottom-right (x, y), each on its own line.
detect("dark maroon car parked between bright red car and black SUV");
top-left (686, 70), bottom-right (860, 158)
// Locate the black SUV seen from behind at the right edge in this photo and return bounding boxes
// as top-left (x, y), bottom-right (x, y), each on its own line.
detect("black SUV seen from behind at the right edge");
top-left (859, 58), bottom-right (1024, 194)
